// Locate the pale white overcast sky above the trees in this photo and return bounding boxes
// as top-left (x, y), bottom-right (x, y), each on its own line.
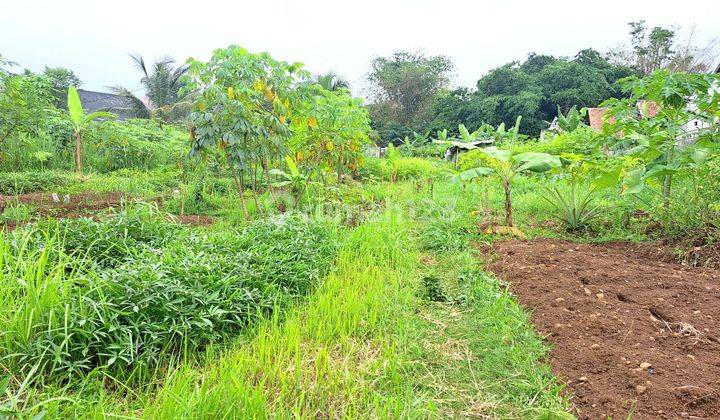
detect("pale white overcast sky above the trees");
top-left (0, 0), bottom-right (720, 97)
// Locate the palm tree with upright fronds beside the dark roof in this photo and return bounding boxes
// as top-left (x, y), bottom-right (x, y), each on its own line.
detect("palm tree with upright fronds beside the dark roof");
top-left (111, 54), bottom-right (187, 122)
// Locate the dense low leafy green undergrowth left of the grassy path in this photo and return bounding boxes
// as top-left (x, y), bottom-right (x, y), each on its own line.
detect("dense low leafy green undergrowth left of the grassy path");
top-left (0, 207), bottom-right (337, 381)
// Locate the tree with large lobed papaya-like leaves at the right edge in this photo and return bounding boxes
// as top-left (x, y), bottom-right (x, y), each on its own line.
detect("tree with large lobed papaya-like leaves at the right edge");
top-left (604, 70), bottom-right (720, 213)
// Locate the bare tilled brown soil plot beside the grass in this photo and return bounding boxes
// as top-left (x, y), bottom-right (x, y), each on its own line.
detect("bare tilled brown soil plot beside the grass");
top-left (489, 239), bottom-right (720, 419)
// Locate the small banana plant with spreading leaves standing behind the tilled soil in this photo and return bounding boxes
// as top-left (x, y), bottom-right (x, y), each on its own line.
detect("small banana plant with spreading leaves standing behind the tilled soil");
top-left (454, 147), bottom-right (562, 228)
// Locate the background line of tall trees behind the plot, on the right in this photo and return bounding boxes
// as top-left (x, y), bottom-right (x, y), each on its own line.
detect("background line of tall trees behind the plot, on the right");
top-left (367, 21), bottom-right (718, 145)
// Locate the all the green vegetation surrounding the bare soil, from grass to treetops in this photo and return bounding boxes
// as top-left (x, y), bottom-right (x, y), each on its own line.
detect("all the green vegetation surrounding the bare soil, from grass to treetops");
top-left (0, 35), bottom-right (720, 419)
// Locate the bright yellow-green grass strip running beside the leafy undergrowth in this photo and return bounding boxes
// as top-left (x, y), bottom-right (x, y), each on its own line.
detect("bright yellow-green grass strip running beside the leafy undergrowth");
top-left (146, 208), bottom-right (426, 418)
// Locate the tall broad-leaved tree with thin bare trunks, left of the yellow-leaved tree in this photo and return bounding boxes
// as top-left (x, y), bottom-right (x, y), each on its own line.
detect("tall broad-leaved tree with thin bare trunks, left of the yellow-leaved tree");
top-left (184, 45), bottom-right (310, 219)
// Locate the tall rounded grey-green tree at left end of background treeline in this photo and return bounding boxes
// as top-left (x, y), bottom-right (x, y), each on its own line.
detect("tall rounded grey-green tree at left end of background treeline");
top-left (367, 51), bottom-right (453, 127)
